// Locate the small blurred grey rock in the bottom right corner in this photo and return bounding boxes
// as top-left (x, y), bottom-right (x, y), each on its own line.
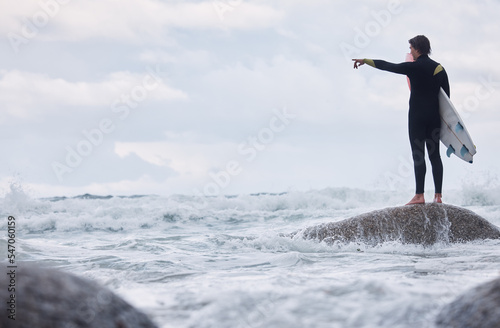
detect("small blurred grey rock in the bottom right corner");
top-left (436, 278), bottom-right (500, 328)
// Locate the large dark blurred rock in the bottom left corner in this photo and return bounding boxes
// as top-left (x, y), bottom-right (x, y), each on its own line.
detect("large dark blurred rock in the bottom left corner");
top-left (0, 262), bottom-right (156, 328)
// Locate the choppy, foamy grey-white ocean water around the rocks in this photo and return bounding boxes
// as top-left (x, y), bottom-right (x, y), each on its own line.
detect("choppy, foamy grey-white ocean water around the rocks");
top-left (0, 186), bottom-right (500, 328)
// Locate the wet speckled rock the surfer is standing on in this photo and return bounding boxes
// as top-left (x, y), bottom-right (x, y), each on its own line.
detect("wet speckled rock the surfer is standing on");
top-left (296, 203), bottom-right (500, 245)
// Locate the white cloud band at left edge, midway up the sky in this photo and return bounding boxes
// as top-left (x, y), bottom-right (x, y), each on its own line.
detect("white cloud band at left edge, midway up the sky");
top-left (0, 69), bottom-right (188, 122)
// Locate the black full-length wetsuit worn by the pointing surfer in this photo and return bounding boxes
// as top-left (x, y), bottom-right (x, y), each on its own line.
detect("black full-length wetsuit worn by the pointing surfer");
top-left (365, 55), bottom-right (450, 194)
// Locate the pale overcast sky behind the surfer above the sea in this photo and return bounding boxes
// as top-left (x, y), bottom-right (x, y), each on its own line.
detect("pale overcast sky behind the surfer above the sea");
top-left (0, 0), bottom-right (500, 197)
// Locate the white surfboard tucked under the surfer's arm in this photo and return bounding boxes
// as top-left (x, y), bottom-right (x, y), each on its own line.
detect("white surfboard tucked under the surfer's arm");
top-left (438, 88), bottom-right (476, 163)
